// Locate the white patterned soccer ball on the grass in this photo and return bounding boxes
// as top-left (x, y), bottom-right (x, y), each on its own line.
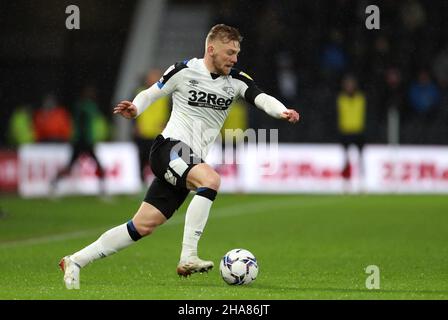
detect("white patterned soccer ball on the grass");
top-left (219, 249), bottom-right (258, 285)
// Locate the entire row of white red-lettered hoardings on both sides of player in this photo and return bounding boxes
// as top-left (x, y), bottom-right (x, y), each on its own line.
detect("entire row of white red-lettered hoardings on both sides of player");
top-left (18, 143), bottom-right (448, 197)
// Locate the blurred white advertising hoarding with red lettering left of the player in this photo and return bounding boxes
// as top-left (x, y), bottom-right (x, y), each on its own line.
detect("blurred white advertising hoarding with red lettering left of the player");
top-left (19, 143), bottom-right (140, 197)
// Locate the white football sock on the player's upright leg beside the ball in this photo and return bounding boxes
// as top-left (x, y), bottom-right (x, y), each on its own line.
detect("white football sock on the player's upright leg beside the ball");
top-left (180, 195), bottom-right (213, 260)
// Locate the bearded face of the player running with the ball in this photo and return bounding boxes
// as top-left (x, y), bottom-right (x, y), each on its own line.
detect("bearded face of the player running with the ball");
top-left (212, 41), bottom-right (240, 75)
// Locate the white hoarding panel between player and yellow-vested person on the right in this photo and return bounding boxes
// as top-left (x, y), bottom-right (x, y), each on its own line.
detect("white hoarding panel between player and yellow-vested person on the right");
top-left (239, 144), bottom-right (352, 193)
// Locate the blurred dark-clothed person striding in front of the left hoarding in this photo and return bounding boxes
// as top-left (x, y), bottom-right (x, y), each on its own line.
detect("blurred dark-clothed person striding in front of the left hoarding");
top-left (52, 86), bottom-right (105, 194)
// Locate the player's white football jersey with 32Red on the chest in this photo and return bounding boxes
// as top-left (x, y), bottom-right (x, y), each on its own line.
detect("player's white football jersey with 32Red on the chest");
top-left (156, 58), bottom-right (262, 159)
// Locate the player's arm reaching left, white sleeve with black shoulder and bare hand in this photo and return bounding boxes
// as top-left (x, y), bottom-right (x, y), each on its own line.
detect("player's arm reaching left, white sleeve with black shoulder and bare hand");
top-left (113, 62), bottom-right (187, 119)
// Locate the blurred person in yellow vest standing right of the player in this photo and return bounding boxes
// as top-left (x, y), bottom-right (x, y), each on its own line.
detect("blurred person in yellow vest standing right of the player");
top-left (336, 75), bottom-right (366, 184)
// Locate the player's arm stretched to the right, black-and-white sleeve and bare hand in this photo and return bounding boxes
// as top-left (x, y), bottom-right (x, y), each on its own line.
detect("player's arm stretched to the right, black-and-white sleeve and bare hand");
top-left (231, 69), bottom-right (300, 123)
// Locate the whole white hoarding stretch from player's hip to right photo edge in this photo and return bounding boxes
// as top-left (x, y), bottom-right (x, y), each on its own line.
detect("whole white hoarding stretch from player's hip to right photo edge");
top-left (207, 144), bottom-right (448, 193)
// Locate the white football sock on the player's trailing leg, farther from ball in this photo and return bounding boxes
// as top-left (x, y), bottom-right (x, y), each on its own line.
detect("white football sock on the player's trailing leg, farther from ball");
top-left (70, 223), bottom-right (135, 268)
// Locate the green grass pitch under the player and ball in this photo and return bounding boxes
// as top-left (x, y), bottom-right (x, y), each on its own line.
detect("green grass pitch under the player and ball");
top-left (0, 194), bottom-right (448, 300)
